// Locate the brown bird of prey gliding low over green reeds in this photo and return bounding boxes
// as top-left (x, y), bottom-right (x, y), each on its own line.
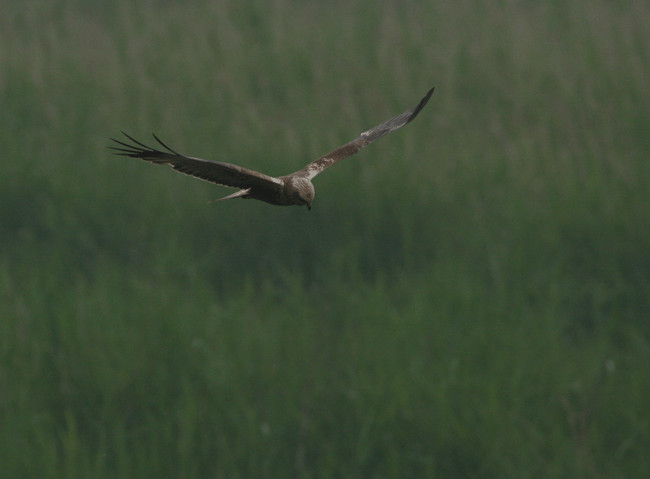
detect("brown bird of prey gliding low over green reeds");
top-left (110, 88), bottom-right (433, 209)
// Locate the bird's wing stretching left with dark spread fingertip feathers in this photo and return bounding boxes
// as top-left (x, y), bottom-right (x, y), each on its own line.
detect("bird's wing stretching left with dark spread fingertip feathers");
top-left (109, 132), bottom-right (282, 188)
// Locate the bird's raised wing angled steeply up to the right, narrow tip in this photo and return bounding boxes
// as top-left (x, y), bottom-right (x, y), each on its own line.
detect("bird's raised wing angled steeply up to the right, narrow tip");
top-left (293, 88), bottom-right (434, 180)
